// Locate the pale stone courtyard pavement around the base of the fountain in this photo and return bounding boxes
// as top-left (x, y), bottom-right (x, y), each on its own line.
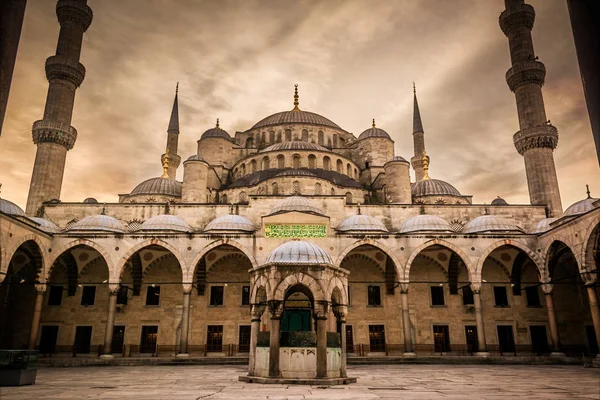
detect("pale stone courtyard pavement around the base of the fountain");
top-left (0, 365), bottom-right (600, 400)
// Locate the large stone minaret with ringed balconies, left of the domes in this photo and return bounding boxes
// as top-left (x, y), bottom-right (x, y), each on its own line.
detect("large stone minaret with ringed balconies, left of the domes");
top-left (27, 0), bottom-right (93, 215)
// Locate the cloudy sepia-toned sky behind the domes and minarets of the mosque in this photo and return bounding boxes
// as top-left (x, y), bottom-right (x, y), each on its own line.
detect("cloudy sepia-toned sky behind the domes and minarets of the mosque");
top-left (0, 0), bottom-right (600, 208)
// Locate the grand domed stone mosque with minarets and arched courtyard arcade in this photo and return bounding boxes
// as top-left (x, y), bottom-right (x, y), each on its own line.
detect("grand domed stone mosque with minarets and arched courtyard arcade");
top-left (0, 0), bottom-right (600, 376)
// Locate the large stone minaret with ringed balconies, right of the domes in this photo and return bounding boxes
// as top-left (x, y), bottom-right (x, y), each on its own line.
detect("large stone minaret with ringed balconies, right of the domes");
top-left (500, 0), bottom-right (562, 217)
